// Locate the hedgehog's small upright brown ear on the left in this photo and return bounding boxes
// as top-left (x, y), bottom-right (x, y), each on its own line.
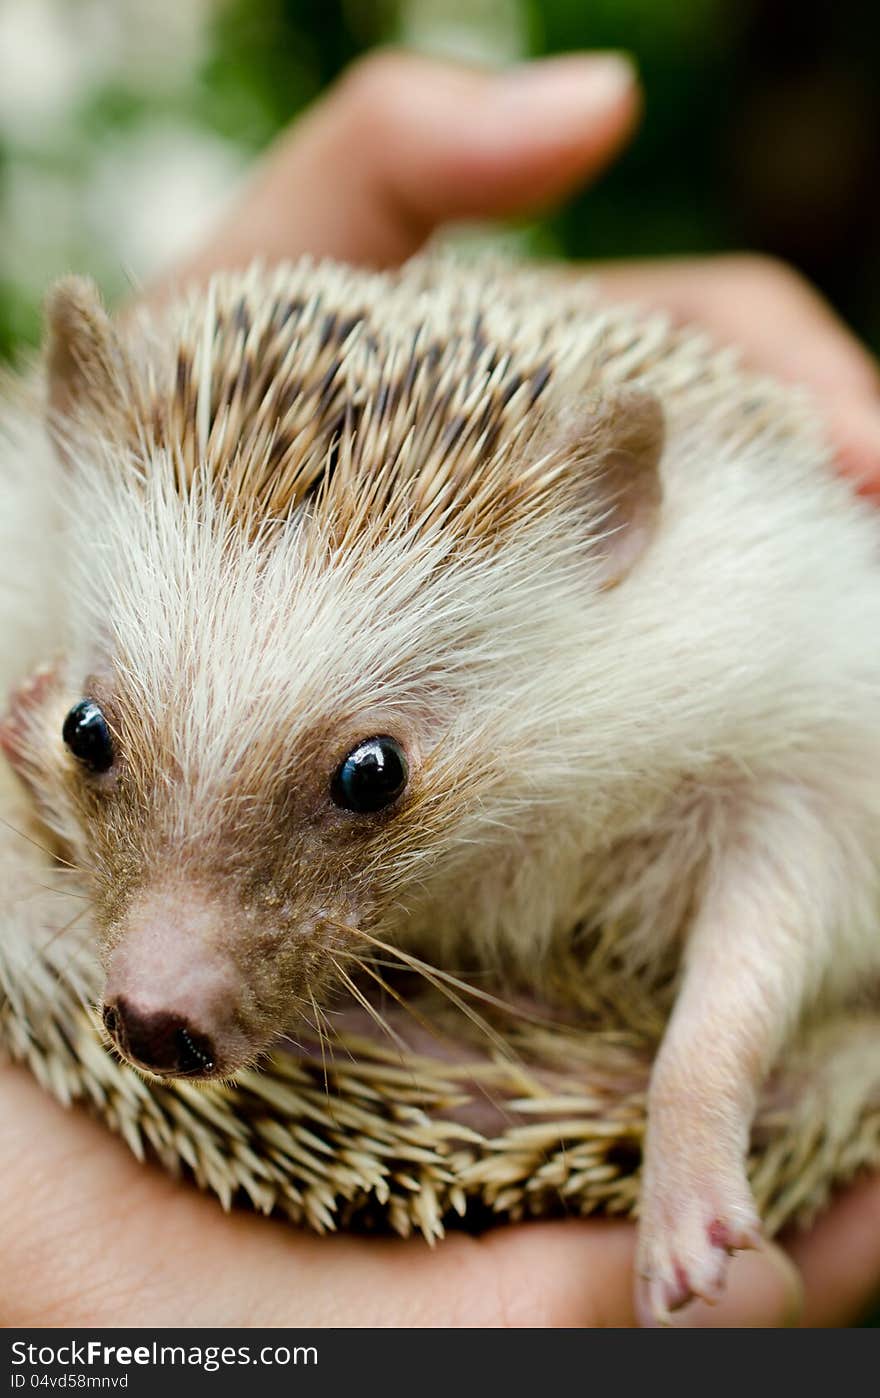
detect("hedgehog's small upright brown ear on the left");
top-left (45, 277), bottom-right (126, 459)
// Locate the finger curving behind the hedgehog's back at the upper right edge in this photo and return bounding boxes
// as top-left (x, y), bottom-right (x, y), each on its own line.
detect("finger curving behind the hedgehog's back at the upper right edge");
top-left (596, 256), bottom-right (880, 493)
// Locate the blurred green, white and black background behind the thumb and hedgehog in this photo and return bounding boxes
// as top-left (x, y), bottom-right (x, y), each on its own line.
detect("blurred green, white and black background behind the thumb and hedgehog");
top-left (0, 0), bottom-right (880, 354)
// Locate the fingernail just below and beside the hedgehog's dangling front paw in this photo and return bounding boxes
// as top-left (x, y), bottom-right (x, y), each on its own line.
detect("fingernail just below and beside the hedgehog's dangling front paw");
top-left (672, 1243), bottom-right (803, 1329)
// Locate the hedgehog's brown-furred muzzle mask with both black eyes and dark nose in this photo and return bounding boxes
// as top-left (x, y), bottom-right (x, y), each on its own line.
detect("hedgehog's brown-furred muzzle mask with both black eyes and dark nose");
top-left (3, 651), bottom-right (439, 1076)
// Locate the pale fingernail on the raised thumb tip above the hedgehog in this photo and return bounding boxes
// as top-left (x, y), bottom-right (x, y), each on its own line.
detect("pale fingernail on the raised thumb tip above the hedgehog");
top-left (492, 53), bottom-right (637, 129)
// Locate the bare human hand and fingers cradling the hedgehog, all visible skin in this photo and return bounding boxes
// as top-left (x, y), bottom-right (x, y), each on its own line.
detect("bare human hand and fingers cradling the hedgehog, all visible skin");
top-left (6, 43), bottom-right (880, 1327)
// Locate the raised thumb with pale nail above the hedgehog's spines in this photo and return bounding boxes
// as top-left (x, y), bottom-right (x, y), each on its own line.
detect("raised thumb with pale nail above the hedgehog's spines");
top-left (159, 52), bottom-right (639, 289)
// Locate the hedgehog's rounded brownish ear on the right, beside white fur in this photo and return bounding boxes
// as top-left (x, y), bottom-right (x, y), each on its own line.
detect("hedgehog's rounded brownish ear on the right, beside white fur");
top-left (557, 384), bottom-right (665, 589)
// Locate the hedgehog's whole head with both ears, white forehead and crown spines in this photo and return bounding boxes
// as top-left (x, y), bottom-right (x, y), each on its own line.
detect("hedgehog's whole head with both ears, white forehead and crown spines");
top-left (0, 268), bottom-right (662, 1076)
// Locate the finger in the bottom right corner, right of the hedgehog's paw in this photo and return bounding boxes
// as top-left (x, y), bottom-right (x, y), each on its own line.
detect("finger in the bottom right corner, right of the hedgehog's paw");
top-left (786, 1179), bottom-right (880, 1327)
